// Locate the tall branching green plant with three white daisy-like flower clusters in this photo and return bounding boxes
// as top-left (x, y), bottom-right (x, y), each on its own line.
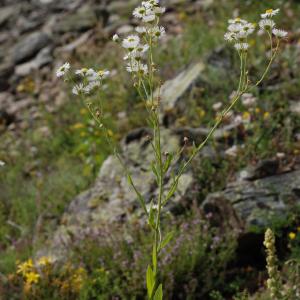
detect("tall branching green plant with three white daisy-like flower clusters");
top-left (57, 0), bottom-right (287, 300)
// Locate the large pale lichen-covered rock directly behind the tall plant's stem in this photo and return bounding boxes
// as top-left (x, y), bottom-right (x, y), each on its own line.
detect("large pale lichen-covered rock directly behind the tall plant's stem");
top-left (43, 128), bottom-right (195, 256)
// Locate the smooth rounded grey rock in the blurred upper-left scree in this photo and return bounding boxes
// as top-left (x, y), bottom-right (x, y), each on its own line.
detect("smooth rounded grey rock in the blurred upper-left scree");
top-left (13, 31), bottom-right (50, 64)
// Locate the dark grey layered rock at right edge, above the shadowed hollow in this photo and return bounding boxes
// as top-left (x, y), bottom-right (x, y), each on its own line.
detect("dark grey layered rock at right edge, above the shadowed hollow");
top-left (203, 170), bottom-right (300, 232)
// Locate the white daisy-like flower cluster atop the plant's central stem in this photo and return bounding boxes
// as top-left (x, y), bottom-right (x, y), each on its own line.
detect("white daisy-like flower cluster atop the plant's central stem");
top-left (113, 0), bottom-right (166, 76)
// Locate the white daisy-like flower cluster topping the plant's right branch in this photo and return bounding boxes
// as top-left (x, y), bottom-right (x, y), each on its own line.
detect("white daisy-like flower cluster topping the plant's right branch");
top-left (224, 9), bottom-right (288, 52)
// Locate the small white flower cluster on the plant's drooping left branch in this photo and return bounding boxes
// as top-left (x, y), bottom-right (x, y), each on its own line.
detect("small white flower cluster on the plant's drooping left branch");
top-left (56, 62), bottom-right (110, 95)
